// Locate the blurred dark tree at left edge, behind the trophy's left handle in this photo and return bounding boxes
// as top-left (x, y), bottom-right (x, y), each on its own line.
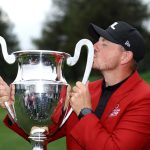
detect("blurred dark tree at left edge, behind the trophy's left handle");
top-left (0, 9), bottom-right (19, 83)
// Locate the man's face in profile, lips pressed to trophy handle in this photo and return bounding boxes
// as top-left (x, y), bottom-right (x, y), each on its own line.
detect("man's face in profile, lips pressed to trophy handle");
top-left (93, 37), bottom-right (123, 71)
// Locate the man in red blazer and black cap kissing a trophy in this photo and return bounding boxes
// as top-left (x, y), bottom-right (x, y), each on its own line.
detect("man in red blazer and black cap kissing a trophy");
top-left (0, 21), bottom-right (150, 150)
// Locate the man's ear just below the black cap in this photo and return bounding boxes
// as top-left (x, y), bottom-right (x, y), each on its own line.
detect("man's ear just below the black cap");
top-left (121, 51), bottom-right (133, 64)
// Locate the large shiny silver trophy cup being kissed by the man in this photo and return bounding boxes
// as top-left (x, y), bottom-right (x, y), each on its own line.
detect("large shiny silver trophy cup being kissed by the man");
top-left (0, 36), bottom-right (94, 150)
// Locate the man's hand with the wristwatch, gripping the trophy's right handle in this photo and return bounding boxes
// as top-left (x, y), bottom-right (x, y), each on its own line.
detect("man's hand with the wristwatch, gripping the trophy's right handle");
top-left (70, 81), bottom-right (92, 115)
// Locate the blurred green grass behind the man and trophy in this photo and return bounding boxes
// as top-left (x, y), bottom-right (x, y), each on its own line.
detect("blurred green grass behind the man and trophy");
top-left (0, 72), bottom-right (150, 150)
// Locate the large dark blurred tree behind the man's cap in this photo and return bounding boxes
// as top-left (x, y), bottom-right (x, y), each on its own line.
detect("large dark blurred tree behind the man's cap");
top-left (33, 0), bottom-right (150, 80)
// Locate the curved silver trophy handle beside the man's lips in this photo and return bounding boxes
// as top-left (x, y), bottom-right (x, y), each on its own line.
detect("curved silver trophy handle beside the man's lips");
top-left (60, 39), bottom-right (94, 127)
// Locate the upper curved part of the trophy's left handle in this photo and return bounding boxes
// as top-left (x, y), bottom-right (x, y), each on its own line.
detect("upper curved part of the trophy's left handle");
top-left (0, 36), bottom-right (16, 64)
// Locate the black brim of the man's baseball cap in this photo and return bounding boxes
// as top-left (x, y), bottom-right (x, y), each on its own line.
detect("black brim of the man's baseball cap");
top-left (88, 23), bottom-right (116, 42)
